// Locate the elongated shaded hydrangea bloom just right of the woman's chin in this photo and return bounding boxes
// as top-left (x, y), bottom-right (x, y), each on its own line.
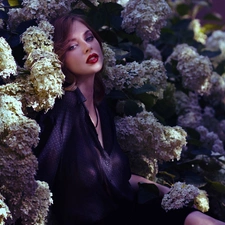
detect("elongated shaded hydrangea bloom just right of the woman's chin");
top-left (104, 59), bottom-right (167, 98)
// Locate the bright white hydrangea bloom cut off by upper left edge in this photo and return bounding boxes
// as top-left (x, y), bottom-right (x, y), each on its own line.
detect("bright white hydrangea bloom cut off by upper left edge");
top-left (0, 37), bottom-right (17, 79)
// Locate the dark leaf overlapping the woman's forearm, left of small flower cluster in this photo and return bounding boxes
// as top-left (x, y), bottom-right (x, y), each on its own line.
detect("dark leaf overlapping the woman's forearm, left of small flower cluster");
top-left (137, 183), bottom-right (159, 204)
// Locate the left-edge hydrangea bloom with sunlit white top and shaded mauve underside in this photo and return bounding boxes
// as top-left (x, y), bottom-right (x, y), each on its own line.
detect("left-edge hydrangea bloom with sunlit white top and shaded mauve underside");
top-left (0, 95), bottom-right (40, 155)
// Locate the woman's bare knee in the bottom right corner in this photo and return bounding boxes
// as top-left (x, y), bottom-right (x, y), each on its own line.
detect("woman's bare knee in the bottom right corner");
top-left (184, 211), bottom-right (225, 225)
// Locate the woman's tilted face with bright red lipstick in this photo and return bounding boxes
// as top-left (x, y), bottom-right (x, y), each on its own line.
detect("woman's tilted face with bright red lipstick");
top-left (64, 21), bottom-right (103, 78)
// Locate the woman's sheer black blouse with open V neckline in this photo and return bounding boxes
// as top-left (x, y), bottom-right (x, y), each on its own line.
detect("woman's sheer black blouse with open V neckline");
top-left (34, 88), bottom-right (134, 225)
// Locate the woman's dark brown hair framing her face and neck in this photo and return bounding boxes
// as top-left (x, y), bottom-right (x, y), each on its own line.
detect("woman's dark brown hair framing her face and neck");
top-left (53, 13), bottom-right (105, 103)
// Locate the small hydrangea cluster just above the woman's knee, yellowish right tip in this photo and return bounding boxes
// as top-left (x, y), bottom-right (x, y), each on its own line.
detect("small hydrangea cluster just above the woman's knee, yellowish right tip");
top-left (161, 182), bottom-right (209, 212)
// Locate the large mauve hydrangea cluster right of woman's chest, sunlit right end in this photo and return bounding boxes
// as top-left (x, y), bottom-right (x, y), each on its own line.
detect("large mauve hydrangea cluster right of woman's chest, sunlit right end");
top-left (116, 111), bottom-right (187, 177)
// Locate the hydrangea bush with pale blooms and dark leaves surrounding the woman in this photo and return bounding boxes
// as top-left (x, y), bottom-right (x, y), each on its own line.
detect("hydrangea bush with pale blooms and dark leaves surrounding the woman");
top-left (0, 0), bottom-right (225, 222)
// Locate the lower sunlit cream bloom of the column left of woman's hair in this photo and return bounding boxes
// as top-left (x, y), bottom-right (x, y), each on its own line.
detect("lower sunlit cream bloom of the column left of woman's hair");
top-left (24, 50), bottom-right (65, 111)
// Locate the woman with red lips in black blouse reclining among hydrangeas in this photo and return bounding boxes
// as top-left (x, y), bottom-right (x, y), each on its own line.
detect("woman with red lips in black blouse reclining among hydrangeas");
top-left (35, 14), bottom-right (224, 225)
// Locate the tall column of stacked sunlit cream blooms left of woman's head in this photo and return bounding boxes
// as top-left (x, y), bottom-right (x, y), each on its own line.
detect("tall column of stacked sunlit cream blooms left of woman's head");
top-left (20, 21), bottom-right (65, 111)
